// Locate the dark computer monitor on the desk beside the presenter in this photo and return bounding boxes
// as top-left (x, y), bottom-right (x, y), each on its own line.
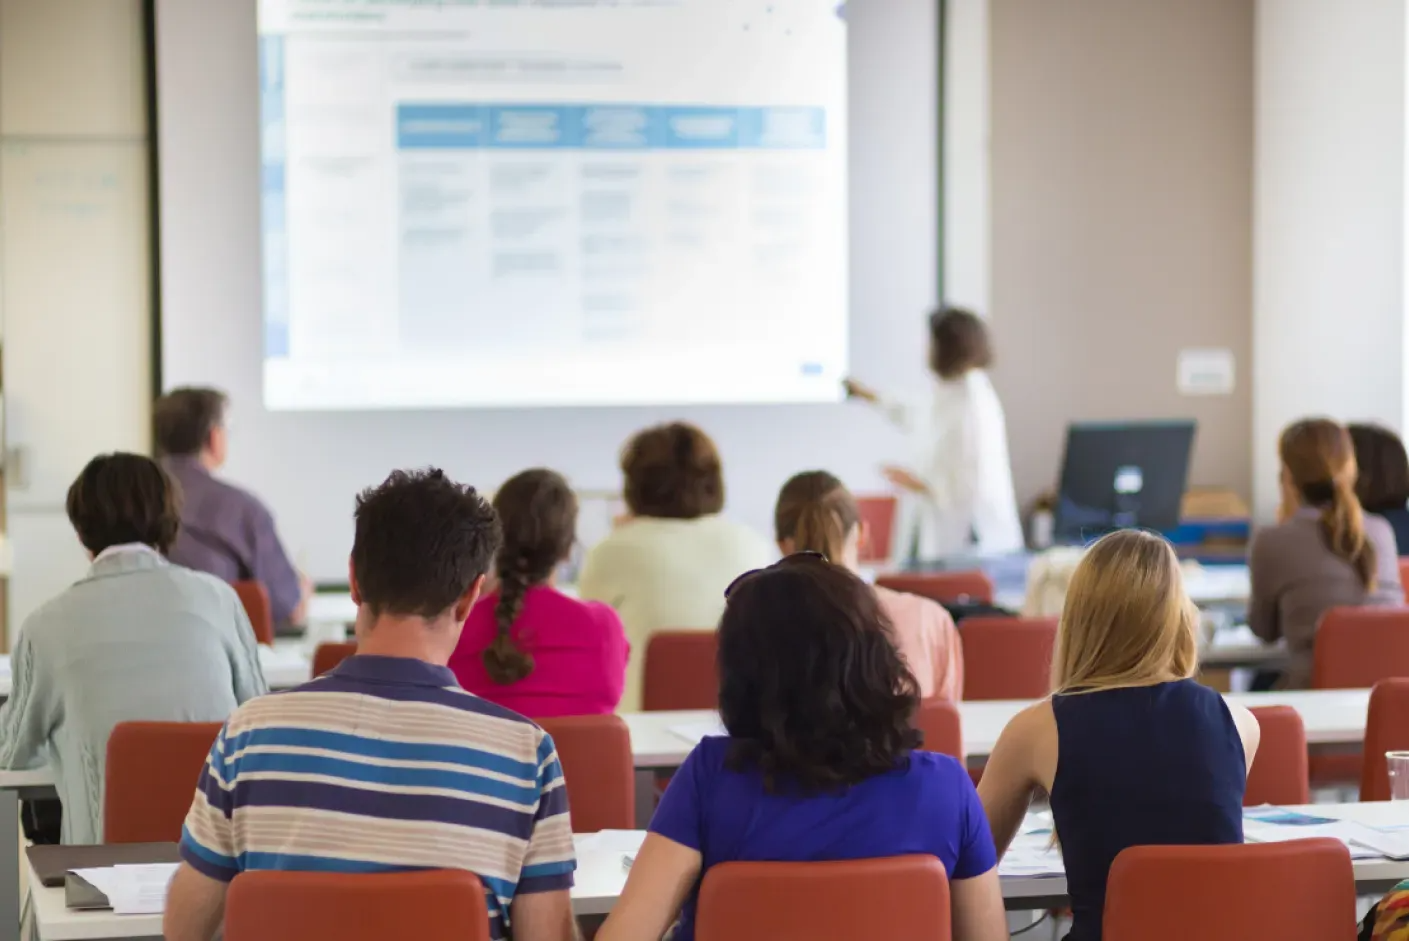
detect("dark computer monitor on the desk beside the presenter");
top-left (1055, 421), bottom-right (1195, 544)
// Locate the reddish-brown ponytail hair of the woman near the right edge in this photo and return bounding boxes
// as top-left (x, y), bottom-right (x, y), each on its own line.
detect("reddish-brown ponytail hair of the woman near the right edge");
top-left (1278, 418), bottom-right (1377, 592)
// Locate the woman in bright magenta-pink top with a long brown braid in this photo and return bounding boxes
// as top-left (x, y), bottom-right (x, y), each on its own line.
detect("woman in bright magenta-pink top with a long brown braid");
top-left (449, 469), bottom-right (630, 718)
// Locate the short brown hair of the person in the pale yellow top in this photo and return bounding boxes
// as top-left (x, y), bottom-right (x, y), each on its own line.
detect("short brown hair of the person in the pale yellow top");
top-left (621, 421), bottom-right (724, 520)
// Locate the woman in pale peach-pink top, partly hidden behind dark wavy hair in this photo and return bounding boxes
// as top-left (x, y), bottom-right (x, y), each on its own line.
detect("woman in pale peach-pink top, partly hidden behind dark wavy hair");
top-left (774, 471), bottom-right (964, 702)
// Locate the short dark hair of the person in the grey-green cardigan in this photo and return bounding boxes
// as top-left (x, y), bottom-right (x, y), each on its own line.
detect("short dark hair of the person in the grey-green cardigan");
top-left (68, 452), bottom-right (180, 555)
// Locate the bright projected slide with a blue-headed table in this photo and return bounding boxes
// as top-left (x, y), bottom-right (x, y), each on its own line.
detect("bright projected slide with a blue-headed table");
top-left (259, 0), bottom-right (847, 410)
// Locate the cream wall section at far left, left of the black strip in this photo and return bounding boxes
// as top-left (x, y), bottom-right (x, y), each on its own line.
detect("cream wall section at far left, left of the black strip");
top-left (0, 0), bottom-right (152, 638)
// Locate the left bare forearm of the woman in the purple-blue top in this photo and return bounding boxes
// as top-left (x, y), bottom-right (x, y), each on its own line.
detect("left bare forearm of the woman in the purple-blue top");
top-left (597, 833), bottom-right (703, 941)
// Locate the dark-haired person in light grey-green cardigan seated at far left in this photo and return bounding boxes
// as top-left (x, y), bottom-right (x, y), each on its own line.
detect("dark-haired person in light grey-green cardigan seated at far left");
top-left (0, 454), bottom-right (266, 844)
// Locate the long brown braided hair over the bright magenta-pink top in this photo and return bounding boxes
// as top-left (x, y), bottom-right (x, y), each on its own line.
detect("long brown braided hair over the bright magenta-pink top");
top-left (482, 468), bottom-right (578, 686)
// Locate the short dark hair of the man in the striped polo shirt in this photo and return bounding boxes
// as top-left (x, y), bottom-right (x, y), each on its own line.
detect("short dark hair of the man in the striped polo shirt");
top-left (352, 468), bottom-right (499, 617)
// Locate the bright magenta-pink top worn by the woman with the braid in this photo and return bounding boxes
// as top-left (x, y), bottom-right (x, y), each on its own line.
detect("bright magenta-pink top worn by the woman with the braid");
top-left (449, 585), bottom-right (631, 718)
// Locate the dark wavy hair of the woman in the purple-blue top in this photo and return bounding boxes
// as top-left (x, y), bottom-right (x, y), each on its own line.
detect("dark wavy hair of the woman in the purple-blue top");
top-left (719, 555), bottom-right (920, 793)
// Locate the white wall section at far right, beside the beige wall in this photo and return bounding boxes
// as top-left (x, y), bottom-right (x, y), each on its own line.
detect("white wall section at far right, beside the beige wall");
top-left (1253, 0), bottom-right (1409, 518)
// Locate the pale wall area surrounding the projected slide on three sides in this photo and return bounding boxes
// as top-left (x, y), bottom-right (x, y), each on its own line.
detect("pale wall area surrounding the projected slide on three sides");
top-left (156, 0), bottom-right (938, 579)
